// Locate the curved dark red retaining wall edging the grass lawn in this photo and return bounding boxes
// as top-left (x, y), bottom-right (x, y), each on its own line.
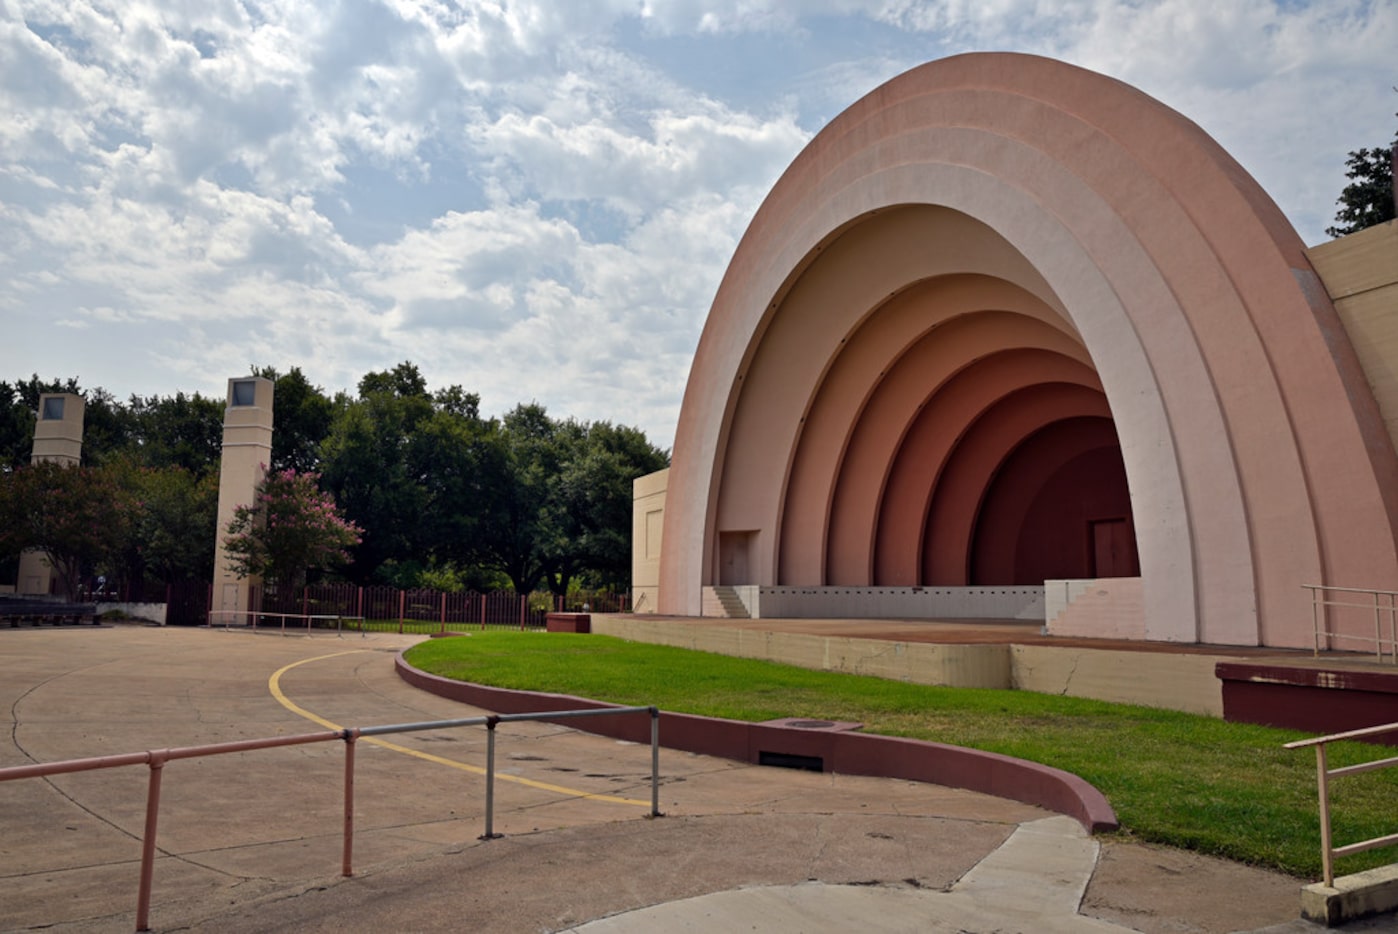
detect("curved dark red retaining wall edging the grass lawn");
top-left (396, 653), bottom-right (1117, 833)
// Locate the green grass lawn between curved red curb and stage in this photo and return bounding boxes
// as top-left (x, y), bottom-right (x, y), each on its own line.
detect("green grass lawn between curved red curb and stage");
top-left (407, 632), bottom-right (1398, 879)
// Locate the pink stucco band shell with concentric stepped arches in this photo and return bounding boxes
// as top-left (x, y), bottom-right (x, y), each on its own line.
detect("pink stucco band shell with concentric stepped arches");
top-left (660, 53), bottom-right (1398, 646)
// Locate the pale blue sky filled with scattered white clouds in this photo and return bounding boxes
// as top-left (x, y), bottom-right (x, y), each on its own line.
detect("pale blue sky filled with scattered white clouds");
top-left (0, 0), bottom-right (1398, 447)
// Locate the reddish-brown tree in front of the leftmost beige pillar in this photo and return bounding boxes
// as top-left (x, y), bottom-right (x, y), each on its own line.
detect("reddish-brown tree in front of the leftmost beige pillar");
top-left (0, 461), bottom-right (130, 600)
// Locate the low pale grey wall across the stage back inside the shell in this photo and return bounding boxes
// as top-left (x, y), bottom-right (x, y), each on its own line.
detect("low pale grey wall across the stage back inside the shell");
top-left (752, 587), bottom-right (1044, 619)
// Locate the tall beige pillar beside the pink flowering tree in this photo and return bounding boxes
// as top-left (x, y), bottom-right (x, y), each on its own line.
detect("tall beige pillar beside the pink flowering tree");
top-left (211, 376), bottom-right (273, 625)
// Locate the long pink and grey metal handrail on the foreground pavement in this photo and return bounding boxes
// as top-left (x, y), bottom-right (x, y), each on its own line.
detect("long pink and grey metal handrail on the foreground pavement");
top-left (0, 706), bottom-right (663, 931)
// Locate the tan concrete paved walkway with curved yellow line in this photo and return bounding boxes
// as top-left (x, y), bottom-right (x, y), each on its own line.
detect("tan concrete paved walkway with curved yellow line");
top-left (0, 626), bottom-right (1391, 934)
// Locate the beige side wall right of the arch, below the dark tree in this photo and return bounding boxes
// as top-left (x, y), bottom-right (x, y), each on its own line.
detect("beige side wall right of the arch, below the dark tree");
top-left (1309, 221), bottom-right (1398, 455)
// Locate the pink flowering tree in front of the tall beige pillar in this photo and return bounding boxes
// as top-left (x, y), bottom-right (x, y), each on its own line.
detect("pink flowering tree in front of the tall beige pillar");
top-left (224, 470), bottom-right (363, 589)
